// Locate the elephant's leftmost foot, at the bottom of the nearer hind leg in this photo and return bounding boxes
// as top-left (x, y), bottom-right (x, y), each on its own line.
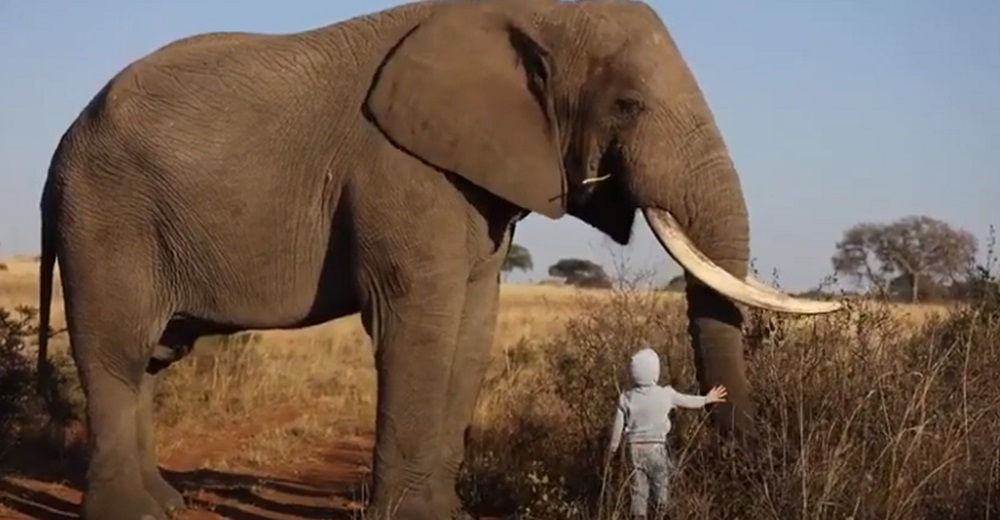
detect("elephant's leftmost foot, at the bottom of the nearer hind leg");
top-left (80, 477), bottom-right (168, 520)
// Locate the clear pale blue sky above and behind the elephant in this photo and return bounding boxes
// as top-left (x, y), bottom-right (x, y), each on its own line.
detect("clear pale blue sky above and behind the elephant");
top-left (0, 0), bottom-right (1000, 288)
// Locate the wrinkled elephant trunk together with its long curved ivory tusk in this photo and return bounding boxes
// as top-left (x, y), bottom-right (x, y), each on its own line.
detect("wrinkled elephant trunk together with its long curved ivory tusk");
top-left (633, 96), bottom-right (840, 433)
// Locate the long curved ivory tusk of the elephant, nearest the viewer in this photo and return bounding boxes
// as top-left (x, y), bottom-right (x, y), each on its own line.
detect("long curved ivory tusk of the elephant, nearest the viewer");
top-left (642, 208), bottom-right (843, 314)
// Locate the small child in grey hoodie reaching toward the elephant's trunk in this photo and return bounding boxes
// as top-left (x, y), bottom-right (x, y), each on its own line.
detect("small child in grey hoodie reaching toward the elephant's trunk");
top-left (608, 348), bottom-right (726, 519)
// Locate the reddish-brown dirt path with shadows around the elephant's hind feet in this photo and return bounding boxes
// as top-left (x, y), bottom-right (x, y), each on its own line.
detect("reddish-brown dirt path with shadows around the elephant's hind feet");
top-left (0, 412), bottom-right (372, 520)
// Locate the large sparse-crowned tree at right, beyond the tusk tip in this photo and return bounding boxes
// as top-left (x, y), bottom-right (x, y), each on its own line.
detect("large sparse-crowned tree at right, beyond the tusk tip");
top-left (831, 216), bottom-right (978, 302)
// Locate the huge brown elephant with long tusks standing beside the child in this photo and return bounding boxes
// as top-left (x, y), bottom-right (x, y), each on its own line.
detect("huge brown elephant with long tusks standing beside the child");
top-left (39, 0), bottom-right (841, 520)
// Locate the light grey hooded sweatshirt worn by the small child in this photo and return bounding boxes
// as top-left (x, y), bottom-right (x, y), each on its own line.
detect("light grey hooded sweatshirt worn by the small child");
top-left (609, 348), bottom-right (708, 452)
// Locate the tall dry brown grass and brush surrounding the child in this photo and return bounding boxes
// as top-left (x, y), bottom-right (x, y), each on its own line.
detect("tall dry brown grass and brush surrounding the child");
top-left (461, 262), bottom-right (1000, 520)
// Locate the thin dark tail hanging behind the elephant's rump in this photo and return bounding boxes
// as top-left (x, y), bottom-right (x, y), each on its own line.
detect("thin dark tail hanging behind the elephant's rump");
top-left (37, 179), bottom-right (56, 405)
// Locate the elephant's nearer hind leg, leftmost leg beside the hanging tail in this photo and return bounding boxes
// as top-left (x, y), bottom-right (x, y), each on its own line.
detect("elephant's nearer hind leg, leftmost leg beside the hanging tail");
top-left (67, 298), bottom-right (168, 520)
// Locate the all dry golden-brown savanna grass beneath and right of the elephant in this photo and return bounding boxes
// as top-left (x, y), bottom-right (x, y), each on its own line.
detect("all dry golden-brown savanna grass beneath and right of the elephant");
top-left (0, 254), bottom-right (1000, 519)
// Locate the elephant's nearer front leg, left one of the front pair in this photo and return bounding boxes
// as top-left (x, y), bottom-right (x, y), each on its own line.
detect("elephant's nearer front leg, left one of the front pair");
top-left (362, 270), bottom-right (465, 520)
